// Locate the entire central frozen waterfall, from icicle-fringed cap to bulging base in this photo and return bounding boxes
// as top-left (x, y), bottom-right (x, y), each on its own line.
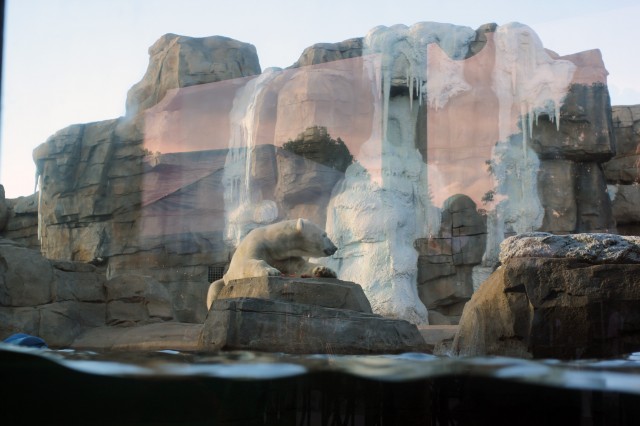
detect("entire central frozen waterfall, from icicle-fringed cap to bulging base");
top-left (327, 23), bottom-right (475, 324)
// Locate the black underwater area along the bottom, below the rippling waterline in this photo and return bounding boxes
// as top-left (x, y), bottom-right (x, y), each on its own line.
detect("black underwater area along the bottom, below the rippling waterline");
top-left (0, 350), bottom-right (640, 425)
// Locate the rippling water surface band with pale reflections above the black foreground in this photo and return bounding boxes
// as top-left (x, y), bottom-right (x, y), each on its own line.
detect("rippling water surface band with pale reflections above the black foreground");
top-left (0, 344), bottom-right (640, 395)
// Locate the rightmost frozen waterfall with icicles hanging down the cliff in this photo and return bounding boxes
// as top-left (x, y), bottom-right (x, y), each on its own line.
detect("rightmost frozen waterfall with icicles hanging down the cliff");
top-left (484, 23), bottom-right (576, 265)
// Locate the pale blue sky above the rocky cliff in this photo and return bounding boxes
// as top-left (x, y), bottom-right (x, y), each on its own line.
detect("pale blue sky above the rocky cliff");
top-left (0, 0), bottom-right (640, 198)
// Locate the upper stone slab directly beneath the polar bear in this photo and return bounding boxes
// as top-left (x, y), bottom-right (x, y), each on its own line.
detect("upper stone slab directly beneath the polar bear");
top-left (218, 277), bottom-right (372, 314)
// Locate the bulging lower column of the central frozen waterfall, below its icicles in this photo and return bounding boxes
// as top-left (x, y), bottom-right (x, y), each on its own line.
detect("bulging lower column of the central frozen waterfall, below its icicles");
top-left (327, 98), bottom-right (439, 324)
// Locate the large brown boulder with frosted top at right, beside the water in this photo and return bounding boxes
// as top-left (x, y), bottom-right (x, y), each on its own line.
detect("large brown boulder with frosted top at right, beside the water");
top-left (453, 233), bottom-right (640, 359)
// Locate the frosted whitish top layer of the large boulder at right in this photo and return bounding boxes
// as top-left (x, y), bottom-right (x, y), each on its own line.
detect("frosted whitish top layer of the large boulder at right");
top-left (500, 232), bottom-right (640, 264)
